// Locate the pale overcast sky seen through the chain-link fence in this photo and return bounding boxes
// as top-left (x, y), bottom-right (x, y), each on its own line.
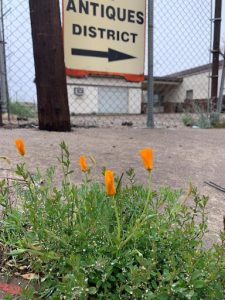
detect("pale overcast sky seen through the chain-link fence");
top-left (3, 0), bottom-right (225, 102)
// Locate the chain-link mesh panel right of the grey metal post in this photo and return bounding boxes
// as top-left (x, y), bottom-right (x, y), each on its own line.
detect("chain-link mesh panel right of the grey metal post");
top-left (150, 0), bottom-right (212, 127)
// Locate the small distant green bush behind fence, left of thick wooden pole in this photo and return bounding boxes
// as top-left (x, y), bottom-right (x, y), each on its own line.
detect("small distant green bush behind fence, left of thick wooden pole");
top-left (9, 101), bottom-right (36, 118)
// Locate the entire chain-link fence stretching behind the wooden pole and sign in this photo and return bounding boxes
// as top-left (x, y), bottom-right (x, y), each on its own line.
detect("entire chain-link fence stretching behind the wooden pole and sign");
top-left (0, 0), bottom-right (222, 128)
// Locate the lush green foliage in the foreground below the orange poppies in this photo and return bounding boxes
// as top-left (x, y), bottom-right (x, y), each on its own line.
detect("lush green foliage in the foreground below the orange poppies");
top-left (0, 143), bottom-right (225, 300)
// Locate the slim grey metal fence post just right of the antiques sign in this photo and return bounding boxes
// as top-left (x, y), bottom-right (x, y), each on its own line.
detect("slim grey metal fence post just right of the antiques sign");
top-left (147, 0), bottom-right (154, 128)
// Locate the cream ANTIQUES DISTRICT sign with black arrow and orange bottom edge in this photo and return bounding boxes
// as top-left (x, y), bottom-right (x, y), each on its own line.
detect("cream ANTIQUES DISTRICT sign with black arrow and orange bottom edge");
top-left (63, 0), bottom-right (146, 81)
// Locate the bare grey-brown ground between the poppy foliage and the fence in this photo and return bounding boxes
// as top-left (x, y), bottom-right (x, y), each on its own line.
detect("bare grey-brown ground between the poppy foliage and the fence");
top-left (0, 128), bottom-right (225, 248)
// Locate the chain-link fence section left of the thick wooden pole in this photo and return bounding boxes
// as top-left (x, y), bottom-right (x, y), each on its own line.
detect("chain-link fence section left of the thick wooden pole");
top-left (2, 0), bottom-right (37, 123)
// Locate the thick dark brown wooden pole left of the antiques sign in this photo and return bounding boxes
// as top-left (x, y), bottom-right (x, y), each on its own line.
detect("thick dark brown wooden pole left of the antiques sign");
top-left (29, 0), bottom-right (71, 131)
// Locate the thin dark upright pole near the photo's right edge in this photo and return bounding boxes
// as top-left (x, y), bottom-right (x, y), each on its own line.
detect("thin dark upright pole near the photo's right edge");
top-left (211, 0), bottom-right (222, 99)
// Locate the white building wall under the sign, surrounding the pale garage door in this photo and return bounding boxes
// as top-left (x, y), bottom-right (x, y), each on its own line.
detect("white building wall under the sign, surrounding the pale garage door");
top-left (67, 77), bottom-right (142, 114)
